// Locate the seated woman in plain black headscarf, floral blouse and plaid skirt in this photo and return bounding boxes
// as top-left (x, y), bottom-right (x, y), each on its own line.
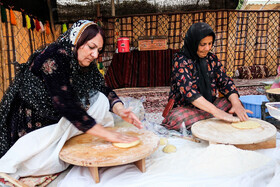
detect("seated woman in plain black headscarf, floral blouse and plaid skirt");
top-left (163, 23), bottom-right (252, 130)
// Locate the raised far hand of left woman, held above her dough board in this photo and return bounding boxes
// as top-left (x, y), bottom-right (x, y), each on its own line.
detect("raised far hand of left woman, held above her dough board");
top-left (113, 103), bottom-right (142, 129)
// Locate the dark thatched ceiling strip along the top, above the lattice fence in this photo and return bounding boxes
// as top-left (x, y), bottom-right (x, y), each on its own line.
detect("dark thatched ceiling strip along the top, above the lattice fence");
top-left (57, 0), bottom-right (238, 23)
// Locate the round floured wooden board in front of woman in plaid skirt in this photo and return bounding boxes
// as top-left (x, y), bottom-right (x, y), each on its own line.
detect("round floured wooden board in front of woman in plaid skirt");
top-left (191, 118), bottom-right (277, 150)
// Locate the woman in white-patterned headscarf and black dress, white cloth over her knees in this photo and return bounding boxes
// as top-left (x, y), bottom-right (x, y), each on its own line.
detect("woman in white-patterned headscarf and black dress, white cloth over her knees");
top-left (0, 20), bottom-right (141, 177)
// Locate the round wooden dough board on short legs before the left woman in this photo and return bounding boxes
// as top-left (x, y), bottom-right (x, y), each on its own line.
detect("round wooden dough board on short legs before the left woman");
top-left (59, 127), bottom-right (159, 183)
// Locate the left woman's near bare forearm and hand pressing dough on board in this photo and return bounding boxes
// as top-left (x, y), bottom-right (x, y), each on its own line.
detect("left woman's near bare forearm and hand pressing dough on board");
top-left (86, 124), bottom-right (138, 143)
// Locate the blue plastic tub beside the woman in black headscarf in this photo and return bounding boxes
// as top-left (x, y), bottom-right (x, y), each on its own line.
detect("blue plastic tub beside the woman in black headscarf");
top-left (239, 95), bottom-right (268, 118)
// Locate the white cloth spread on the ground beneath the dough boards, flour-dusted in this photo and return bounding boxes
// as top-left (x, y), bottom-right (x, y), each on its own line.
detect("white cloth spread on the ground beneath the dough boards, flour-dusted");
top-left (58, 133), bottom-right (280, 187)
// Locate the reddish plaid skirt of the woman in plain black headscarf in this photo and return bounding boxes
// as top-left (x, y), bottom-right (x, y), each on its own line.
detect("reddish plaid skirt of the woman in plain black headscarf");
top-left (162, 97), bottom-right (231, 131)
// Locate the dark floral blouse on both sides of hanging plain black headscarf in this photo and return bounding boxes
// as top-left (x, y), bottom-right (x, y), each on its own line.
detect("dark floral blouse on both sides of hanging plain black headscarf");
top-left (169, 53), bottom-right (238, 107)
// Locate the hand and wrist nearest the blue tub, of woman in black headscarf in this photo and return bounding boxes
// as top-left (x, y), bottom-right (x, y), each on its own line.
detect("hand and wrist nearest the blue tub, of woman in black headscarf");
top-left (229, 94), bottom-right (253, 121)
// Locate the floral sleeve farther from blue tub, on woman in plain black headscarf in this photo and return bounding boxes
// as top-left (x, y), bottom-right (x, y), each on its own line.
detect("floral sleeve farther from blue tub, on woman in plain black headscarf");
top-left (172, 55), bottom-right (201, 103)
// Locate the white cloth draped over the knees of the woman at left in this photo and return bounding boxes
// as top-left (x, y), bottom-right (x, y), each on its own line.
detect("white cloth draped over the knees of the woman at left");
top-left (0, 92), bottom-right (114, 178)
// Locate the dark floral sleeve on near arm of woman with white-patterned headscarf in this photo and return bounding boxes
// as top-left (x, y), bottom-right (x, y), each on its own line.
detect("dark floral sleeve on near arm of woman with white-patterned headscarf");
top-left (31, 46), bottom-right (96, 132)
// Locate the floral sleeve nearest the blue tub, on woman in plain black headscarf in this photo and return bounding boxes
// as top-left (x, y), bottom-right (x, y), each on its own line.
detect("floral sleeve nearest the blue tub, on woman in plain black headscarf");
top-left (212, 55), bottom-right (239, 98)
